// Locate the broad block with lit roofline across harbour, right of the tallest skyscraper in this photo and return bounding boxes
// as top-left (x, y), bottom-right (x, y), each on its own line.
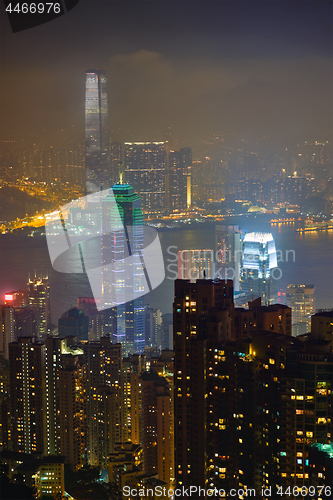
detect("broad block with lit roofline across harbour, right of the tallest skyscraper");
top-left (124, 142), bottom-right (167, 213)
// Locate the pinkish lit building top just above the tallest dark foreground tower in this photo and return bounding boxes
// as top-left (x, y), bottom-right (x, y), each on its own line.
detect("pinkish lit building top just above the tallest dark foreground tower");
top-left (178, 250), bottom-right (214, 282)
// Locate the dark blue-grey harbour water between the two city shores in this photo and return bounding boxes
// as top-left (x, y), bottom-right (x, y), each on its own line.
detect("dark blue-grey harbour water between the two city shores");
top-left (0, 216), bottom-right (333, 324)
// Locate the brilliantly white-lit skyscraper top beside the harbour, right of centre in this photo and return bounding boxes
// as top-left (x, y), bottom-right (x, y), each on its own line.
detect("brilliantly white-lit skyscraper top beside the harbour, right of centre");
top-left (241, 233), bottom-right (280, 304)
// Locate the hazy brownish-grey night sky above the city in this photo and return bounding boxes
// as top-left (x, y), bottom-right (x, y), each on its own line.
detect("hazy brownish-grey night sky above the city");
top-left (1, 0), bottom-right (333, 145)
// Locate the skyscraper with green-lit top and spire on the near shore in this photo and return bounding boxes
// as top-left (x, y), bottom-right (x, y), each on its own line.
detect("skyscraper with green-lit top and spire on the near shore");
top-left (102, 181), bottom-right (145, 355)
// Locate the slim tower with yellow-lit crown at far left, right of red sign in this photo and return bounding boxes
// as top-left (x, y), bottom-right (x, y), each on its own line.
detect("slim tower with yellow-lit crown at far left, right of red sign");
top-left (27, 278), bottom-right (51, 338)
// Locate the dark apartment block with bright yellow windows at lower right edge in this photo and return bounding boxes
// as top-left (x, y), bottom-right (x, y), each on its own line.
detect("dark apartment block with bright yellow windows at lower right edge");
top-left (279, 340), bottom-right (333, 488)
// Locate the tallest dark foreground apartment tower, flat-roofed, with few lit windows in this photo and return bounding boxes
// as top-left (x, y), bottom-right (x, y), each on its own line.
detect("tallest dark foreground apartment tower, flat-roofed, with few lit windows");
top-left (173, 280), bottom-right (233, 488)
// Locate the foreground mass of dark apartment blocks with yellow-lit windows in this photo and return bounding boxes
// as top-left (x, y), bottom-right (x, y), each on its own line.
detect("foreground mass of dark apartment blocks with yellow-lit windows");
top-left (0, 279), bottom-right (333, 495)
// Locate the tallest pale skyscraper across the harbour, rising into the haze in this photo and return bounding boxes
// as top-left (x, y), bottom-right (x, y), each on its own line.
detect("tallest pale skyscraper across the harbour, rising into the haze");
top-left (85, 69), bottom-right (112, 194)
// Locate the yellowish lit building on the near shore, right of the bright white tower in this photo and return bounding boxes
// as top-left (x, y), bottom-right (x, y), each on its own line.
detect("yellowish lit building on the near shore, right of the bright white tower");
top-left (286, 285), bottom-right (315, 336)
